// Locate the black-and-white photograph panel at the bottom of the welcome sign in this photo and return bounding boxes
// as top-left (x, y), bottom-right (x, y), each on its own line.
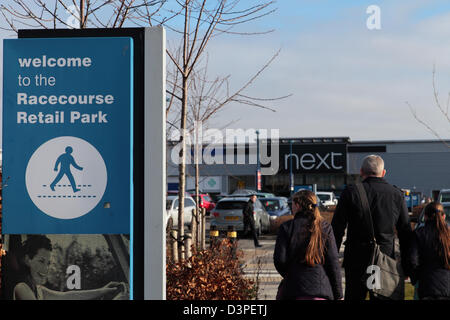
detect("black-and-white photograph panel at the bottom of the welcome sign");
top-left (2, 234), bottom-right (130, 300)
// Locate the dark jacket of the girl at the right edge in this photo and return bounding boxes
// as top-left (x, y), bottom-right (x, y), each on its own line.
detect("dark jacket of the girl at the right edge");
top-left (410, 221), bottom-right (450, 299)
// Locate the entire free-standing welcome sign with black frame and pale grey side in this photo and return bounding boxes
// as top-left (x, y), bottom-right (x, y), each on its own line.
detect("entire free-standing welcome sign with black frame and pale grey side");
top-left (2, 27), bottom-right (165, 299)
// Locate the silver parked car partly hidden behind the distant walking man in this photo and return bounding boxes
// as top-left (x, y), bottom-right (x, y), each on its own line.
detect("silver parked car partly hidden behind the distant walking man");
top-left (211, 197), bottom-right (270, 235)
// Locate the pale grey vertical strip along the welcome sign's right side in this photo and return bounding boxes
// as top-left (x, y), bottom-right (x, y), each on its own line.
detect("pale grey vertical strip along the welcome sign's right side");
top-left (144, 27), bottom-right (166, 300)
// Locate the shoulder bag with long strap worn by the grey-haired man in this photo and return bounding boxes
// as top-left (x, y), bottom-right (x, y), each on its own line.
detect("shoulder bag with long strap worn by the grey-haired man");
top-left (356, 183), bottom-right (405, 300)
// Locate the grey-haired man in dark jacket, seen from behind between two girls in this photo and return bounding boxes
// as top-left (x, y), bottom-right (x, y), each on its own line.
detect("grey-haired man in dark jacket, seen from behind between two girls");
top-left (331, 155), bottom-right (412, 300)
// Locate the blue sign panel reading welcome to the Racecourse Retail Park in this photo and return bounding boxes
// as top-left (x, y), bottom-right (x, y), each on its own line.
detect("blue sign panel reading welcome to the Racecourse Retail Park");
top-left (3, 37), bottom-right (133, 234)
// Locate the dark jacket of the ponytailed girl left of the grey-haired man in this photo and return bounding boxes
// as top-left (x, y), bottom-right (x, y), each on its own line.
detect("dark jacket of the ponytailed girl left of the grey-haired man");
top-left (273, 212), bottom-right (343, 300)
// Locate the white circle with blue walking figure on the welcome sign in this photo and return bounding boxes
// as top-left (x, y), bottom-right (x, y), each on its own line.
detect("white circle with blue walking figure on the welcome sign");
top-left (25, 136), bottom-right (107, 219)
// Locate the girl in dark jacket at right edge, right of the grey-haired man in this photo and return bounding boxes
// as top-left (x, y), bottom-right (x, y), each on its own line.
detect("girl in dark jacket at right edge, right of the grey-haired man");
top-left (411, 202), bottom-right (450, 300)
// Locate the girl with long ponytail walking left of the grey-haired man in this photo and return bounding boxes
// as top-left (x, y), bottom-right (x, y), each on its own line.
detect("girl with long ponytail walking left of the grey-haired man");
top-left (273, 190), bottom-right (343, 300)
